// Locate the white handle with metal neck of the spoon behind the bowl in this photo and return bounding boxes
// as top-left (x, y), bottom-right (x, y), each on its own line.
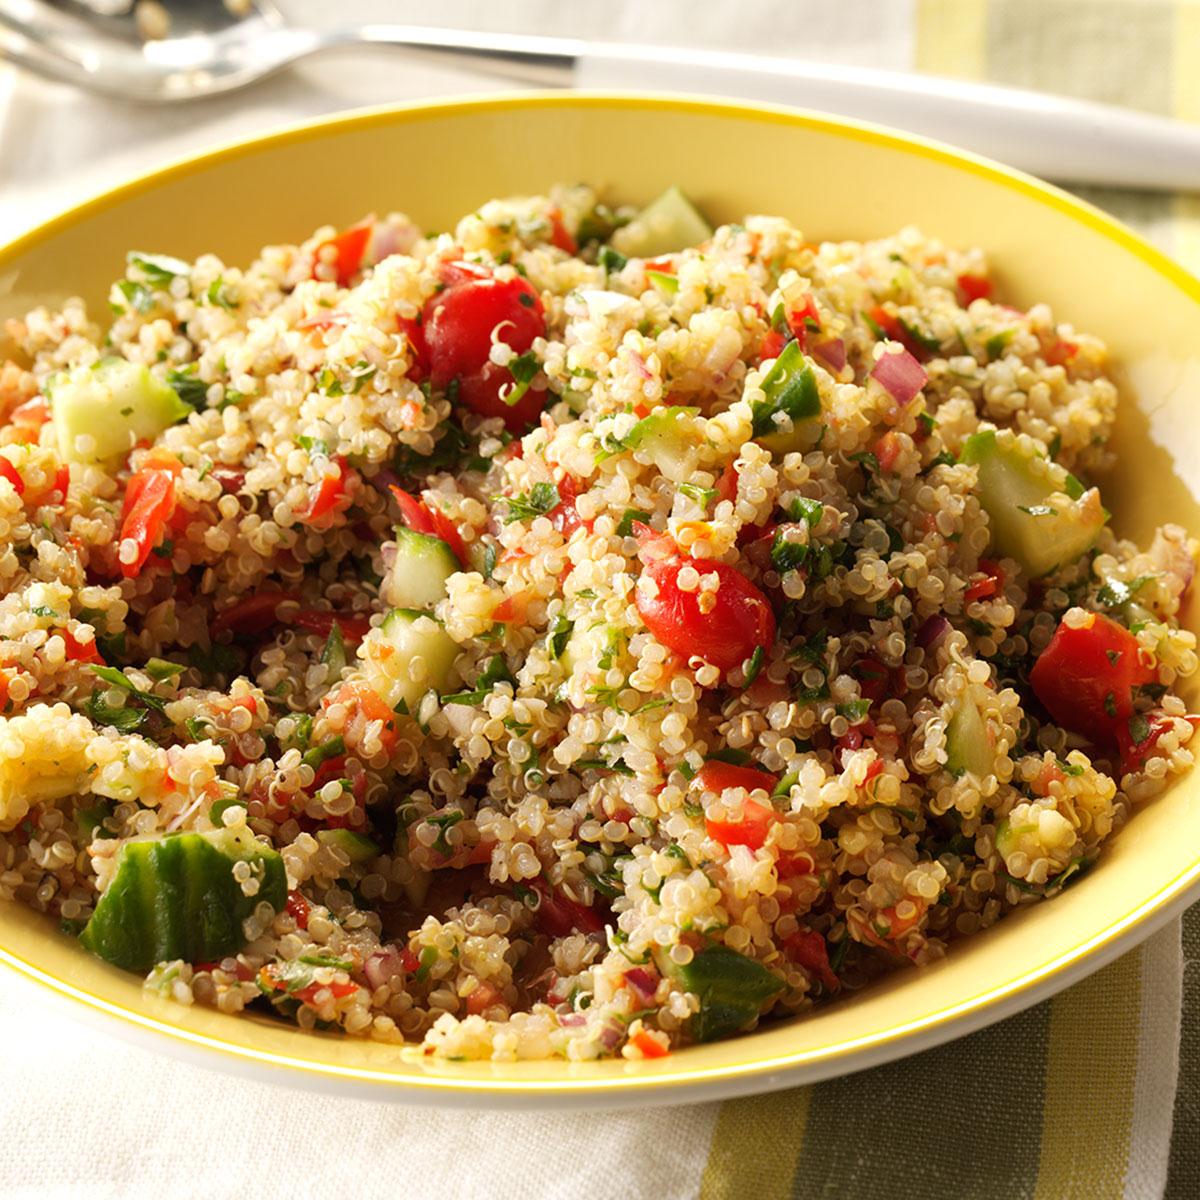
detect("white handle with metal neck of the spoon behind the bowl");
top-left (347, 25), bottom-right (1200, 191)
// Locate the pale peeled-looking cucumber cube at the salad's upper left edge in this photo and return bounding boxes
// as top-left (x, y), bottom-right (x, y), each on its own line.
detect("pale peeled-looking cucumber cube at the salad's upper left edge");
top-left (46, 358), bottom-right (192, 466)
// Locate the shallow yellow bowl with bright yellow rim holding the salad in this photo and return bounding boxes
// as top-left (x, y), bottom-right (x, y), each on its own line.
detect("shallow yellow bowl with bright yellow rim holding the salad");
top-left (0, 95), bottom-right (1200, 1106)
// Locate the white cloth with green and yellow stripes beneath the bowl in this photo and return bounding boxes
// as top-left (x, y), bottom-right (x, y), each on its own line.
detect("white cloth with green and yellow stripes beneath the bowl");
top-left (0, 0), bottom-right (1200, 1200)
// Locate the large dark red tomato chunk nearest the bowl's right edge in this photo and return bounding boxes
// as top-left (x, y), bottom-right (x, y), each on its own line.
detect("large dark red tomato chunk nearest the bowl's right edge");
top-left (1030, 613), bottom-right (1157, 745)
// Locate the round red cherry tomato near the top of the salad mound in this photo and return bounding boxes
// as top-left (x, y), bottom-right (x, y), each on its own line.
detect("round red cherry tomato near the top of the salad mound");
top-left (425, 276), bottom-right (546, 431)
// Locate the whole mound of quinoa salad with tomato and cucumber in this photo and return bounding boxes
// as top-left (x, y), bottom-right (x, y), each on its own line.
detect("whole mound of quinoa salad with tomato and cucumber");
top-left (0, 186), bottom-right (1198, 1060)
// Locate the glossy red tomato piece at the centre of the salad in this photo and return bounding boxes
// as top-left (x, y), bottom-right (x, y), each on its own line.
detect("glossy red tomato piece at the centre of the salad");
top-left (634, 523), bottom-right (775, 671)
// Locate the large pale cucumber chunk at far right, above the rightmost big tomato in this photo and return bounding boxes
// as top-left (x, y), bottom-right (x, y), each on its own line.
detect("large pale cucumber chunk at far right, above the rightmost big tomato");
top-left (960, 430), bottom-right (1108, 576)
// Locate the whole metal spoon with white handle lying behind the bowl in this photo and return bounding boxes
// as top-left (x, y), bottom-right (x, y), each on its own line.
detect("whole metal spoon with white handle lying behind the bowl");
top-left (0, 0), bottom-right (1200, 191)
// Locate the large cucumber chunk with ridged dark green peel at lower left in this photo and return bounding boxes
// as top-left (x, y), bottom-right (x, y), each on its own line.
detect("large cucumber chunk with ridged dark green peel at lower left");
top-left (79, 827), bottom-right (288, 971)
